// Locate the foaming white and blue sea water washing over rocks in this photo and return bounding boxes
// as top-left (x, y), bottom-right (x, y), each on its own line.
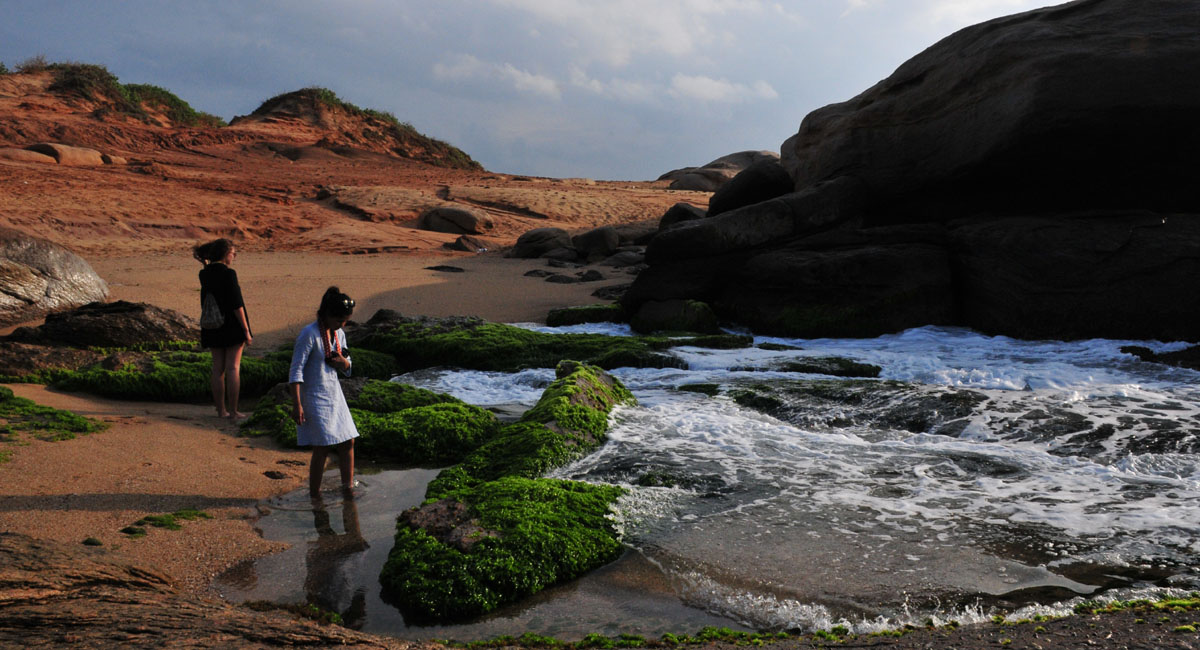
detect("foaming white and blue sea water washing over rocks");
top-left (220, 325), bottom-right (1200, 638)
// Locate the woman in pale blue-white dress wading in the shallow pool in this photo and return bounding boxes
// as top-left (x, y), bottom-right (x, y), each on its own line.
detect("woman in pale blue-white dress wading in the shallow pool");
top-left (288, 287), bottom-right (359, 499)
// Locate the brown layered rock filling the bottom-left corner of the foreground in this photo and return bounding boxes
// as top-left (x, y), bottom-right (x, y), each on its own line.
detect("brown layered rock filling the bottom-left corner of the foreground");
top-left (0, 532), bottom-right (418, 648)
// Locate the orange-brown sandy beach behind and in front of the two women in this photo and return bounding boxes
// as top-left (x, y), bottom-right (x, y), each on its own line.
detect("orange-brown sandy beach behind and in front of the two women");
top-left (0, 247), bottom-right (630, 602)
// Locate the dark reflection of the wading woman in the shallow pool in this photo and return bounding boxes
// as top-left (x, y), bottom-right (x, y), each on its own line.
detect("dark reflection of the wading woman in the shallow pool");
top-left (304, 499), bottom-right (368, 630)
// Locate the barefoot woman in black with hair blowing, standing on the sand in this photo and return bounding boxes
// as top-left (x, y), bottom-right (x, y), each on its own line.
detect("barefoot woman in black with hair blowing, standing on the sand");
top-left (192, 239), bottom-right (254, 420)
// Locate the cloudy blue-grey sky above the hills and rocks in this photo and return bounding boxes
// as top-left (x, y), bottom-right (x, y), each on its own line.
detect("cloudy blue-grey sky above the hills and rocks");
top-left (0, 0), bottom-right (1058, 180)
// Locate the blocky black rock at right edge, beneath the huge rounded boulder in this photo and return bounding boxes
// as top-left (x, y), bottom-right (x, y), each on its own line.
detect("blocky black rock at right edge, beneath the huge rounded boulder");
top-left (950, 212), bottom-right (1200, 341)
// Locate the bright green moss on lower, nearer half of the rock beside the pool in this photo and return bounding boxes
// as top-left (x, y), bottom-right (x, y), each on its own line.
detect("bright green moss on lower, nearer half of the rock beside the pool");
top-left (379, 476), bottom-right (623, 621)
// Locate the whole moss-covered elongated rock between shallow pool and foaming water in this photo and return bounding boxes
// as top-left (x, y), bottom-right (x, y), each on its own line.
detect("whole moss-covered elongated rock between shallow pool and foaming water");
top-left (379, 361), bottom-right (636, 621)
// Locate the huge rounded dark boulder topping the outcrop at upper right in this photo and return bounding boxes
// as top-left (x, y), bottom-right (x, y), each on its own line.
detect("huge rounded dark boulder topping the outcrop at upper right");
top-left (781, 0), bottom-right (1200, 221)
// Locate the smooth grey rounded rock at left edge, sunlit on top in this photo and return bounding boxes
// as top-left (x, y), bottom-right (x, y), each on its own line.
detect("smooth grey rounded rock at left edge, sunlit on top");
top-left (0, 228), bottom-right (108, 325)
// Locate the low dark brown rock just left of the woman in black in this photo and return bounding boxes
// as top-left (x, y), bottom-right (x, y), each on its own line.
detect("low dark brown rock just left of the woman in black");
top-left (8, 300), bottom-right (200, 348)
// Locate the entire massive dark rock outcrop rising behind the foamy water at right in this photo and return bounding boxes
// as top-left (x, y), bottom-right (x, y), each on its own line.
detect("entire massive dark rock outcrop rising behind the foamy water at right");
top-left (623, 0), bottom-right (1200, 339)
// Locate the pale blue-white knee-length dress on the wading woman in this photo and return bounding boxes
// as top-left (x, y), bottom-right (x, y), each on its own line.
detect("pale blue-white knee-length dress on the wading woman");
top-left (288, 323), bottom-right (359, 446)
